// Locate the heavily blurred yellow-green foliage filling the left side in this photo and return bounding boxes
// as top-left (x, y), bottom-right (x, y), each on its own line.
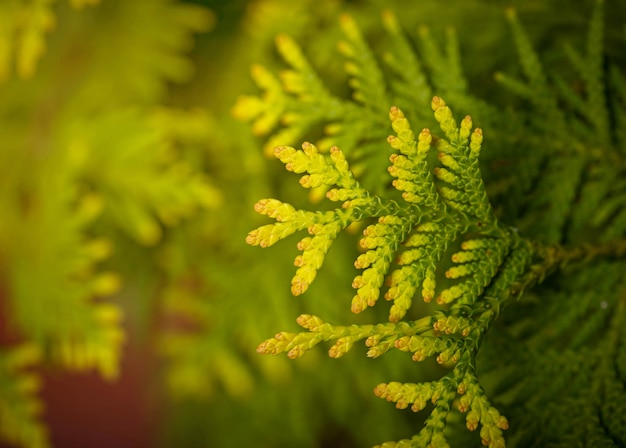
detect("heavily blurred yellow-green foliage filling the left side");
top-left (0, 0), bottom-right (220, 447)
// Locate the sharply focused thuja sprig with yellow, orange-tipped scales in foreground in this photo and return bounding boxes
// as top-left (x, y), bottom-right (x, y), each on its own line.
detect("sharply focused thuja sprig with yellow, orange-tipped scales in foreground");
top-left (247, 97), bottom-right (532, 446)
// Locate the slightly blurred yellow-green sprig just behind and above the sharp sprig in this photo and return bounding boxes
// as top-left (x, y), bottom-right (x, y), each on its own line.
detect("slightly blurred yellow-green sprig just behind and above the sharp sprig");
top-left (233, 11), bottom-right (482, 193)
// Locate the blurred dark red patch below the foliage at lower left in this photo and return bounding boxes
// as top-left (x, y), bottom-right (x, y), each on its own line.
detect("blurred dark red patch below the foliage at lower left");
top-left (0, 292), bottom-right (159, 448)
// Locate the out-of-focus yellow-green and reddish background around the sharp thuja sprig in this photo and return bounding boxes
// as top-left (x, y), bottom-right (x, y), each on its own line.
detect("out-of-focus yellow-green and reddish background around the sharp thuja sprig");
top-left (0, 0), bottom-right (623, 448)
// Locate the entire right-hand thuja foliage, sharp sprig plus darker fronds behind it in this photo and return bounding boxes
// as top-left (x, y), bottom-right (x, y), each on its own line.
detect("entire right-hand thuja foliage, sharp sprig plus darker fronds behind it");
top-left (245, 1), bottom-right (626, 447)
